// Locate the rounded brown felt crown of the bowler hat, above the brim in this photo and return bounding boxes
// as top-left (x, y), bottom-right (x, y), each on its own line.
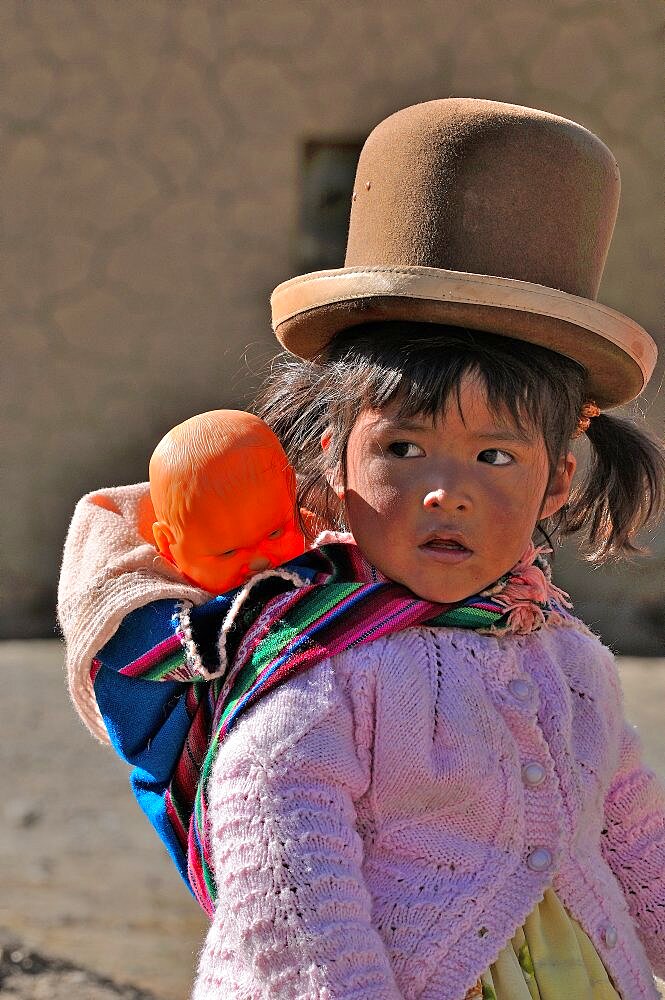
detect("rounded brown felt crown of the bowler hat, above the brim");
top-left (345, 98), bottom-right (620, 299)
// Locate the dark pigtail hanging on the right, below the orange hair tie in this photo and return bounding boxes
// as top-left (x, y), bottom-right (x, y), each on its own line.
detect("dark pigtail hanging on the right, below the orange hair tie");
top-left (560, 413), bottom-right (665, 563)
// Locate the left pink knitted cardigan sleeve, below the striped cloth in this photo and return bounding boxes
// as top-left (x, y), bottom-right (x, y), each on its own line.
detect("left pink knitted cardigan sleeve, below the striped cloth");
top-left (193, 658), bottom-right (401, 1000)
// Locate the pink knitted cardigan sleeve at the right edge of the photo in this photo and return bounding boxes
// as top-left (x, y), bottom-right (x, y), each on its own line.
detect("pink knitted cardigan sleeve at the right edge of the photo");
top-left (602, 724), bottom-right (665, 976)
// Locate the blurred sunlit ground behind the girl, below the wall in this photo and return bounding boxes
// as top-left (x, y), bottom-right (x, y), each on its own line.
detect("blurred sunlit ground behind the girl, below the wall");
top-left (0, 640), bottom-right (665, 1000)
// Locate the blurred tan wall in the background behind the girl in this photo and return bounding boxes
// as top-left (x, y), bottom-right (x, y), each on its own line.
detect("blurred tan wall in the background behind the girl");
top-left (0, 0), bottom-right (665, 652)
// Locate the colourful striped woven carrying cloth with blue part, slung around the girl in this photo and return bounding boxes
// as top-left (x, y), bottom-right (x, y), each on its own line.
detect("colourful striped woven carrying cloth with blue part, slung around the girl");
top-left (91, 542), bottom-right (567, 916)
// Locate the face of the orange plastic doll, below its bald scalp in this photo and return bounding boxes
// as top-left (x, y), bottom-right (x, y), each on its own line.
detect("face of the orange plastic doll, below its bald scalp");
top-left (170, 460), bottom-right (305, 594)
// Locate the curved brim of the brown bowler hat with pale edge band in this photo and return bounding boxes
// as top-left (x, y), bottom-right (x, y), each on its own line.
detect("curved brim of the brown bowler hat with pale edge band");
top-left (271, 267), bottom-right (658, 409)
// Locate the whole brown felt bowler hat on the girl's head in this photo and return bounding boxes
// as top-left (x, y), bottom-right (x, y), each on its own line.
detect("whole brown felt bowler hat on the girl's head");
top-left (271, 98), bottom-right (657, 407)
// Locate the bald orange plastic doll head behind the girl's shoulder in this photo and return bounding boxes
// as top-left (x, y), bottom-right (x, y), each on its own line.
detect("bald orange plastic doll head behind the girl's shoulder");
top-left (150, 410), bottom-right (305, 593)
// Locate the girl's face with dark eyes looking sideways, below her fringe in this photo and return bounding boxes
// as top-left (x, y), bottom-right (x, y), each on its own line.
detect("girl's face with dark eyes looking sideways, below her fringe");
top-left (335, 378), bottom-right (575, 603)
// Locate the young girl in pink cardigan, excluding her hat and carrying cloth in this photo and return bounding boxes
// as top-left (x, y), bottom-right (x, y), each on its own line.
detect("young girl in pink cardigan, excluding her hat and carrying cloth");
top-left (232, 323), bottom-right (665, 1000)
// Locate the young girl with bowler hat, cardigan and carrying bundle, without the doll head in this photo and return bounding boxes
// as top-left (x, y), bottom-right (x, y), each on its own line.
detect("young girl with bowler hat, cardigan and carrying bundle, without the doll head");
top-left (60, 100), bottom-right (665, 1000)
